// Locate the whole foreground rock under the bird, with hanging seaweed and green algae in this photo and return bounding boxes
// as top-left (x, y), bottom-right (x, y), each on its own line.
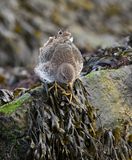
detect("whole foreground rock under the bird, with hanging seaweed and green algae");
top-left (0, 66), bottom-right (132, 160)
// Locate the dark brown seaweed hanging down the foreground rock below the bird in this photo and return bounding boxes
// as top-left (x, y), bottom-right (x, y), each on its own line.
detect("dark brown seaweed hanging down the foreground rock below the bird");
top-left (23, 80), bottom-right (132, 160)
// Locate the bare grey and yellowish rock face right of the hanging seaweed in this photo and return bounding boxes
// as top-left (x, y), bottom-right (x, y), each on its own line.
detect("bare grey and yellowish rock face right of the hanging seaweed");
top-left (83, 65), bottom-right (132, 127)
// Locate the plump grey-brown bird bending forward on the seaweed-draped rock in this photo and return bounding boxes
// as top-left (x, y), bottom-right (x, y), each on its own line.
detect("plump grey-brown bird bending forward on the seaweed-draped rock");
top-left (34, 30), bottom-right (83, 99)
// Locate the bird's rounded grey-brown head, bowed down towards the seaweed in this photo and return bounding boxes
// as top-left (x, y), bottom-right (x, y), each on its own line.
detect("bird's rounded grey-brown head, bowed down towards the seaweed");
top-left (57, 63), bottom-right (75, 84)
